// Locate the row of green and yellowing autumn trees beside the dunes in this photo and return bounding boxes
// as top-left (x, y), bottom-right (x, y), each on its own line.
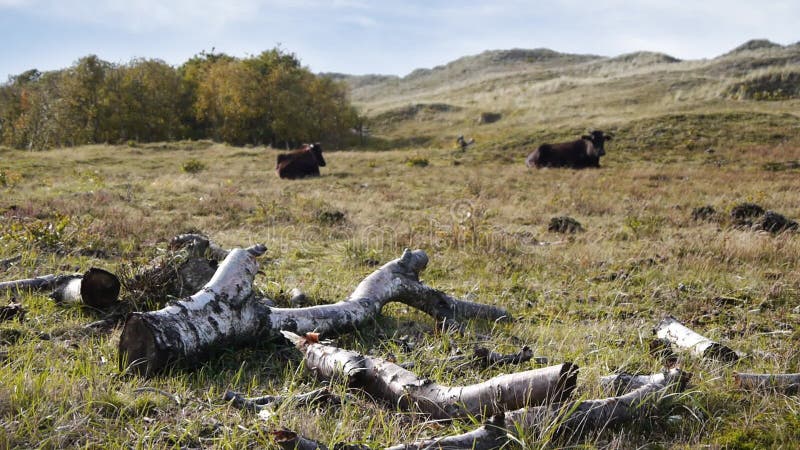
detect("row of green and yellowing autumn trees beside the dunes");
top-left (0, 48), bottom-right (358, 149)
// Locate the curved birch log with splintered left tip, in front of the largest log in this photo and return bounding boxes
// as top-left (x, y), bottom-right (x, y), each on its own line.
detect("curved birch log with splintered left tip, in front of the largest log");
top-left (283, 332), bottom-right (578, 419)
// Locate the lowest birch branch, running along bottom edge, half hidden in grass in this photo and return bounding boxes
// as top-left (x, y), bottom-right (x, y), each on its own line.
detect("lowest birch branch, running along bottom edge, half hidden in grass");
top-left (273, 369), bottom-right (682, 450)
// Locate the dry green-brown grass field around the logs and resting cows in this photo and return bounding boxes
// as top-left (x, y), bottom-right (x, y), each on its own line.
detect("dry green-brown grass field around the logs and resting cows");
top-left (0, 40), bottom-right (800, 448)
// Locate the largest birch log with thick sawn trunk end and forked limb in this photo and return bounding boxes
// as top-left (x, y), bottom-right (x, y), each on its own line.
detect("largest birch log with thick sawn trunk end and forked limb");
top-left (119, 245), bottom-right (509, 375)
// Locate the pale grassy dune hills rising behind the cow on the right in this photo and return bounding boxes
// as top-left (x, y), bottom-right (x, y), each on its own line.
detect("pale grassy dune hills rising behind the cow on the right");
top-left (342, 40), bottom-right (800, 151)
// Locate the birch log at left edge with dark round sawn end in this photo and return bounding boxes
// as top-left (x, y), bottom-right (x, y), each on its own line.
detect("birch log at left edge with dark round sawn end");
top-left (0, 267), bottom-right (120, 308)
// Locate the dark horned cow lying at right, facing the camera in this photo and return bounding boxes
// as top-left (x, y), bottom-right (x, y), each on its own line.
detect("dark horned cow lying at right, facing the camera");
top-left (525, 130), bottom-right (612, 169)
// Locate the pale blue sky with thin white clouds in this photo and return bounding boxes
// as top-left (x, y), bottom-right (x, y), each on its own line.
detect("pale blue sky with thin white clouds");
top-left (0, 0), bottom-right (800, 82)
